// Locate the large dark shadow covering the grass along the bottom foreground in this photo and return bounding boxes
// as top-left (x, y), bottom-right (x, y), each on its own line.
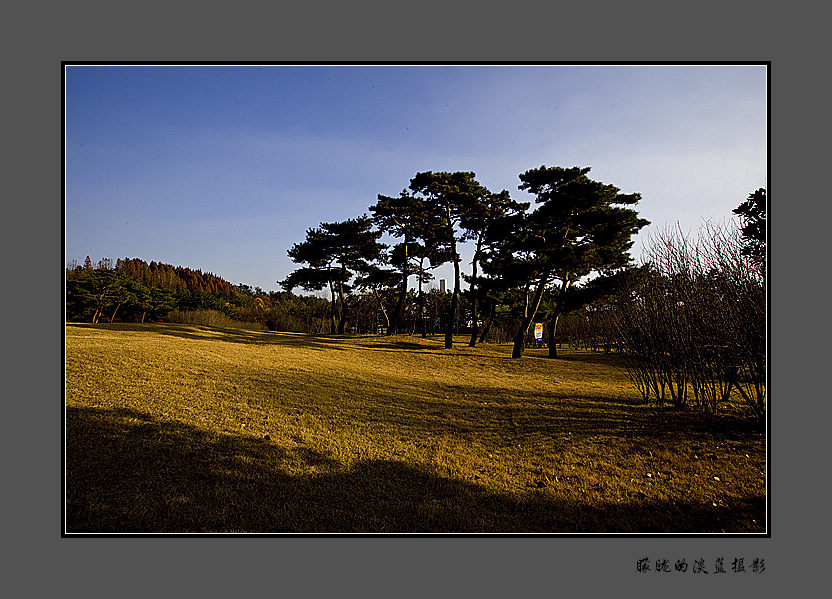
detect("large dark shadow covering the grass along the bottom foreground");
top-left (66, 408), bottom-right (765, 533)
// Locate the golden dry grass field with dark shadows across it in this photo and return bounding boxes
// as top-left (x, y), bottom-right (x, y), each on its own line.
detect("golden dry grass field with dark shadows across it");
top-left (66, 324), bottom-right (766, 533)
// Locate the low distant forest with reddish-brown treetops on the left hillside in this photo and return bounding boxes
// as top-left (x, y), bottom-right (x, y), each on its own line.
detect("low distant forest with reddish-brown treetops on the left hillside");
top-left (66, 257), bottom-right (462, 334)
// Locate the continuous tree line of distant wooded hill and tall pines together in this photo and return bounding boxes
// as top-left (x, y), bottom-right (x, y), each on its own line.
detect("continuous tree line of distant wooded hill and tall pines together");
top-left (67, 166), bottom-right (647, 357)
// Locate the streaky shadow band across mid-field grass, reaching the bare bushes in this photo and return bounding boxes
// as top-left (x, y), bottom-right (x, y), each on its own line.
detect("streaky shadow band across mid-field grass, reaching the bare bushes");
top-left (368, 387), bottom-right (765, 452)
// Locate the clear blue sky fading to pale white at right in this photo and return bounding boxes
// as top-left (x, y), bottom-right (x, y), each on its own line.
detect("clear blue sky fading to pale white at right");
top-left (65, 65), bottom-right (768, 291)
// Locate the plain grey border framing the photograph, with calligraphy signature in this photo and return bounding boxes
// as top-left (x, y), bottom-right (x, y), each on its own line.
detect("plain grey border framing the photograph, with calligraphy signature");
top-left (14, 2), bottom-right (827, 597)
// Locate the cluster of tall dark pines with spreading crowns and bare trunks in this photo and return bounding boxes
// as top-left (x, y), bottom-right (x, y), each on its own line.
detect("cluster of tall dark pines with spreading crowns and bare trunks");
top-left (280, 166), bottom-right (648, 357)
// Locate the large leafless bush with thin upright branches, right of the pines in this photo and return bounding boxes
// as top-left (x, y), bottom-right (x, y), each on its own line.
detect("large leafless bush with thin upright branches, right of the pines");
top-left (617, 224), bottom-right (766, 418)
